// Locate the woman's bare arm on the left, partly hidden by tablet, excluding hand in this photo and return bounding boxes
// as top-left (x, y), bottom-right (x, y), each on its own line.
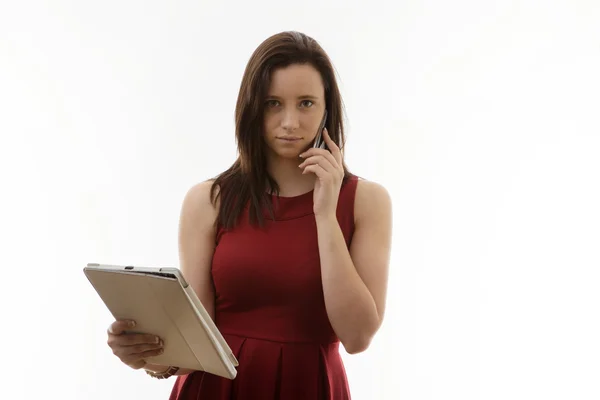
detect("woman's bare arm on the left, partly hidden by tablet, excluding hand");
top-left (144, 181), bottom-right (218, 375)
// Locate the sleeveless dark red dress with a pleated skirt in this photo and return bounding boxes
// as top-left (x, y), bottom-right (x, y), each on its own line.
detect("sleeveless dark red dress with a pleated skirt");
top-left (170, 175), bottom-right (358, 400)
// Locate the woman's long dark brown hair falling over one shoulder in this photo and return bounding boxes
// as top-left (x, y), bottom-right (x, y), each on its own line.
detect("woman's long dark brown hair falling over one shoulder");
top-left (211, 31), bottom-right (350, 229)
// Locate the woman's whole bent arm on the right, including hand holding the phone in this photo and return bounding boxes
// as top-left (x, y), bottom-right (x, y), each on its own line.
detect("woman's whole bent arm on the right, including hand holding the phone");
top-left (298, 129), bottom-right (392, 354)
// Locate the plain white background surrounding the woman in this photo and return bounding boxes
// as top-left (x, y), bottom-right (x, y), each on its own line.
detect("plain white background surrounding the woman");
top-left (0, 0), bottom-right (600, 400)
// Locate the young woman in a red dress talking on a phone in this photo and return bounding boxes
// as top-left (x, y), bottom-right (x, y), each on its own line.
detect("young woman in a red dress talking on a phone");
top-left (108, 32), bottom-right (392, 400)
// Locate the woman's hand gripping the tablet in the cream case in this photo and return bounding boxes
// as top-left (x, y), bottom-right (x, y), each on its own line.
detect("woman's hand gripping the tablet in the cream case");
top-left (107, 320), bottom-right (163, 369)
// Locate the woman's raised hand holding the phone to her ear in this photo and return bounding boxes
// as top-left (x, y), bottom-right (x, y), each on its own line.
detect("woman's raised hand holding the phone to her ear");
top-left (299, 128), bottom-right (344, 218)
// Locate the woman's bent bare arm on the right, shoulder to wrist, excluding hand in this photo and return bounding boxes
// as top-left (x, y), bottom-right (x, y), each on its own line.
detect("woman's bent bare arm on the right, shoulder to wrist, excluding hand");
top-left (316, 181), bottom-right (392, 354)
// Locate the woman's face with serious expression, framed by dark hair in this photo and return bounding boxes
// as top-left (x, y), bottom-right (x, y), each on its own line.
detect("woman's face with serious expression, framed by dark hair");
top-left (264, 64), bottom-right (325, 161)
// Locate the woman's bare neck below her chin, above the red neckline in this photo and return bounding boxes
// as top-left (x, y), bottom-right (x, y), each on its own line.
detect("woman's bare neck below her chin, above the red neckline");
top-left (267, 157), bottom-right (315, 197)
